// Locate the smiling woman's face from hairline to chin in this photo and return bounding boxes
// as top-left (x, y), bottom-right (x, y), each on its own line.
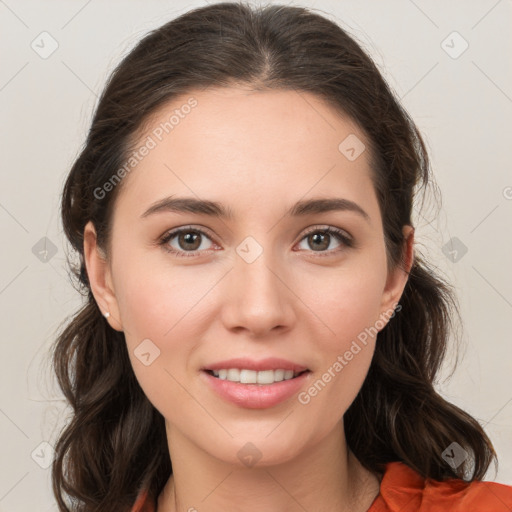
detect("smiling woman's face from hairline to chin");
top-left (85, 88), bottom-right (412, 470)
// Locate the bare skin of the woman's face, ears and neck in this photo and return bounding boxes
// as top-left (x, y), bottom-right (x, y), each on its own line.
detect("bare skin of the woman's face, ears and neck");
top-left (84, 87), bottom-right (414, 512)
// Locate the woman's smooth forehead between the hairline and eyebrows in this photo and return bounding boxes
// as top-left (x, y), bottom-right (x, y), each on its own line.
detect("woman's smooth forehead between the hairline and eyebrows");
top-left (113, 87), bottom-right (373, 222)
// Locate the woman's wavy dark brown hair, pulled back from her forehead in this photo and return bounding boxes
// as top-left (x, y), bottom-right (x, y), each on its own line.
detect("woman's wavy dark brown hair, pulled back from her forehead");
top-left (52, 2), bottom-right (496, 512)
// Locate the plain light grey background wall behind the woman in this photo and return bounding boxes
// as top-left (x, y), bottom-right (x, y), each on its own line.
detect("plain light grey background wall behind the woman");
top-left (0, 0), bottom-right (512, 512)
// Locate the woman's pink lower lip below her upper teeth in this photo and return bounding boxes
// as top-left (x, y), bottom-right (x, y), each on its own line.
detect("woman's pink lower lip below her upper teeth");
top-left (201, 370), bottom-right (311, 409)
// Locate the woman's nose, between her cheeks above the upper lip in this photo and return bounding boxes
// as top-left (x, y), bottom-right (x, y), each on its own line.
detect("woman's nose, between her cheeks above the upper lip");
top-left (221, 246), bottom-right (297, 338)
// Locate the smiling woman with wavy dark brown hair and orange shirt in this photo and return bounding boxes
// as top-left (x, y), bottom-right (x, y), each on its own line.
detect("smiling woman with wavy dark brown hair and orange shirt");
top-left (52, 3), bottom-right (512, 512)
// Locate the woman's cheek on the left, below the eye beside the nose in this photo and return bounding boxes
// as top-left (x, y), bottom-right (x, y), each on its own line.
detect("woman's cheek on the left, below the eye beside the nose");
top-left (115, 252), bottom-right (213, 396)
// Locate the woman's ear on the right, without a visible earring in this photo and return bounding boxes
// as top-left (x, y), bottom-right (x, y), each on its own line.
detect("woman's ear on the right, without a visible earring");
top-left (380, 225), bottom-right (414, 323)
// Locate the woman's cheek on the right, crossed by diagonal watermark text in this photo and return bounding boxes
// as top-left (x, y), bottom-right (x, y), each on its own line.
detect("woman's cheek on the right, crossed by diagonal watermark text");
top-left (292, 259), bottom-right (386, 416)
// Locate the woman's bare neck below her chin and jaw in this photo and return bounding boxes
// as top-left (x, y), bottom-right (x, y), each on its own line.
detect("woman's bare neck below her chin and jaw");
top-left (158, 420), bottom-right (380, 512)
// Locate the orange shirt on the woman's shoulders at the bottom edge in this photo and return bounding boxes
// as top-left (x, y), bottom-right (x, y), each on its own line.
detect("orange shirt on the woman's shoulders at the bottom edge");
top-left (132, 462), bottom-right (512, 512)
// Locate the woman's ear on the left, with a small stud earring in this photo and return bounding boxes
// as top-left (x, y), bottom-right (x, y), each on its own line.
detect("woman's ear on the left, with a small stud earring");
top-left (84, 221), bottom-right (123, 332)
